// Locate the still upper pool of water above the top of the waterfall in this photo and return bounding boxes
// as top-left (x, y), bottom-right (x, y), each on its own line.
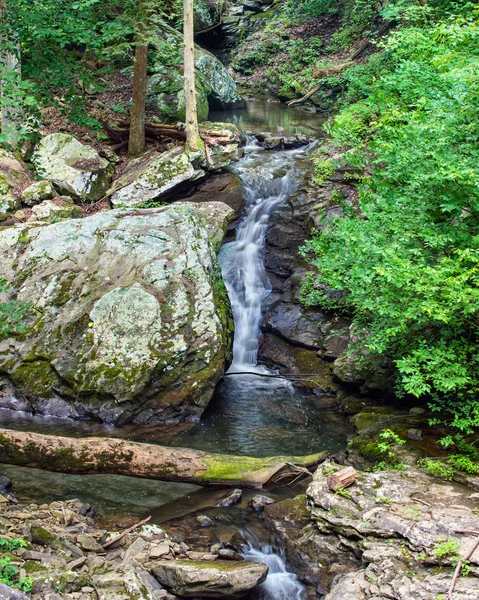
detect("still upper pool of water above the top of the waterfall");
top-left (208, 100), bottom-right (327, 137)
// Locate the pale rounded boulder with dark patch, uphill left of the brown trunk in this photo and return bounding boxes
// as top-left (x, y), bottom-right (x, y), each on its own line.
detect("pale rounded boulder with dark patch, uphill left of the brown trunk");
top-left (33, 133), bottom-right (114, 202)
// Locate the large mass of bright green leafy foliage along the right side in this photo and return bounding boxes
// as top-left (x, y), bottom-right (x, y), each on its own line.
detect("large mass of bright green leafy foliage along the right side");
top-left (304, 3), bottom-right (479, 434)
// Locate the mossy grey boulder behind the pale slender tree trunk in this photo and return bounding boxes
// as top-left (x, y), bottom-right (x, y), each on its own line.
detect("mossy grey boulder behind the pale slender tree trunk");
top-left (147, 23), bottom-right (243, 121)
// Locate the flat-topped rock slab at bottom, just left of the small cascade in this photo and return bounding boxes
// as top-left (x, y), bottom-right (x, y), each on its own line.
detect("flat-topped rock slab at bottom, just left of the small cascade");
top-left (152, 560), bottom-right (268, 600)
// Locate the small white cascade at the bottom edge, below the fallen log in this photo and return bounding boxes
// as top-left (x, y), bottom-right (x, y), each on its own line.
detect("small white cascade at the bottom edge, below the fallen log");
top-left (243, 541), bottom-right (304, 600)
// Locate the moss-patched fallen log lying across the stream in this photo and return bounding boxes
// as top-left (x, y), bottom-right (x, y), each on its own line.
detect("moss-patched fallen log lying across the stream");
top-left (0, 429), bottom-right (327, 489)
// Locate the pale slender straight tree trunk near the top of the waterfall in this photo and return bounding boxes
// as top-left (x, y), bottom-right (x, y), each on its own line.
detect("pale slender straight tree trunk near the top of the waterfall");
top-left (183, 0), bottom-right (204, 152)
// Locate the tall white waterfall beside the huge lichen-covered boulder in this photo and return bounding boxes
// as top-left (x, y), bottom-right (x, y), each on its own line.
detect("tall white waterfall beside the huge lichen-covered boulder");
top-left (220, 141), bottom-right (304, 372)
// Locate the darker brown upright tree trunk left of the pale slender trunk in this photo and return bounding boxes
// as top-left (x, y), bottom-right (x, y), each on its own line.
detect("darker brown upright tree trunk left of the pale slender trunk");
top-left (128, 1), bottom-right (148, 156)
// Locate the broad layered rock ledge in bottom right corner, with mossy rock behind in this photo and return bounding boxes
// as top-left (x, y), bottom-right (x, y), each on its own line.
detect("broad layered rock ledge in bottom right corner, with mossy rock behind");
top-left (264, 394), bottom-right (479, 600)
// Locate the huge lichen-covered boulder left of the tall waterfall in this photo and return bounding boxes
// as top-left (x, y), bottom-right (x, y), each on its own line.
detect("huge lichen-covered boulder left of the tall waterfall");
top-left (0, 202), bottom-right (234, 424)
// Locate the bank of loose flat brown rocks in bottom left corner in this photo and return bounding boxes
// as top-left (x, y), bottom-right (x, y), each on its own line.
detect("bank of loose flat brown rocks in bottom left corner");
top-left (0, 500), bottom-right (268, 600)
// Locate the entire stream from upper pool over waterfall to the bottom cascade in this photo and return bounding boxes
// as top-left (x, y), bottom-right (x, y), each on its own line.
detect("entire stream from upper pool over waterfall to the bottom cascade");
top-left (0, 102), bottom-right (349, 600)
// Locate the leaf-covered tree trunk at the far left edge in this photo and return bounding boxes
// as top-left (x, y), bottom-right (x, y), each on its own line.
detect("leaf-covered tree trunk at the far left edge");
top-left (0, 0), bottom-right (22, 148)
